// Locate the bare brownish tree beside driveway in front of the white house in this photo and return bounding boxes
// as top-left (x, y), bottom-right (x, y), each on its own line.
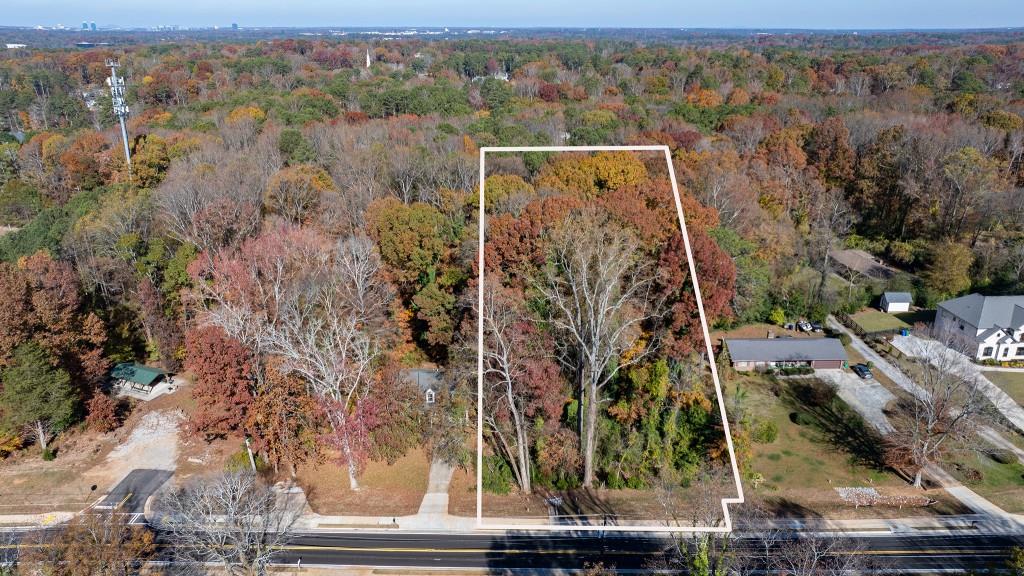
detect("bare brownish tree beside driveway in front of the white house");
top-left (886, 340), bottom-right (985, 488)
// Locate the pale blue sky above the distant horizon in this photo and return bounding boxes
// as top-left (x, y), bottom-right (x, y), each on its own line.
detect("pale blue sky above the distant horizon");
top-left (6, 0), bottom-right (1024, 30)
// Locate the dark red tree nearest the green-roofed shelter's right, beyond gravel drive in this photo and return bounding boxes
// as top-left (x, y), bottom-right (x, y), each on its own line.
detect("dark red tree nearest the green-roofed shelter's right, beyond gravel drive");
top-left (185, 326), bottom-right (253, 438)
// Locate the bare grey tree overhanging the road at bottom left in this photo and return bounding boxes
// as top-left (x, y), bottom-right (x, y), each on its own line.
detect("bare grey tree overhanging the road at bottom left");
top-left (159, 472), bottom-right (301, 576)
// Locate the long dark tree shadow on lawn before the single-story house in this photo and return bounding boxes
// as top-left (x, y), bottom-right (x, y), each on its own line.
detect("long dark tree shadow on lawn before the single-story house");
top-left (782, 380), bottom-right (887, 470)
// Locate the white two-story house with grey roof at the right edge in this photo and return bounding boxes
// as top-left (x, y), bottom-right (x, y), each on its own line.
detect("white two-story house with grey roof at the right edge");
top-left (935, 294), bottom-right (1024, 362)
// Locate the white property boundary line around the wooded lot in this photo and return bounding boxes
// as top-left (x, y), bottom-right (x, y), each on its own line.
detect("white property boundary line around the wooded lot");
top-left (476, 146), bottom-right (743, 532)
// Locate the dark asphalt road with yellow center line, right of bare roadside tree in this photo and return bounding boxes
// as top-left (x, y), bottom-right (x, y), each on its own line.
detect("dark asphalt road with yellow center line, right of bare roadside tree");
top-left (266, 533), bottom-right (1024, 573)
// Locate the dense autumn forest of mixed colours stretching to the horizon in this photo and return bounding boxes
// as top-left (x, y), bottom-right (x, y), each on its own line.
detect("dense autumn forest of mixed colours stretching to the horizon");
top-left (0, 33), bottom-right (1024, 492)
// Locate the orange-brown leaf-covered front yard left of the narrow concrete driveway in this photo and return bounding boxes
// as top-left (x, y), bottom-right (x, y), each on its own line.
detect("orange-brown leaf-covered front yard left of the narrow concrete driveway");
top-left (298, 449), bottom-right (430, 517)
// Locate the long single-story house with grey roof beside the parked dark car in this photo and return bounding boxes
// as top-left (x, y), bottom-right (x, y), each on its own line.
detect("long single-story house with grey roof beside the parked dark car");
top-left (725, 338), bottom-right (847, 371)
